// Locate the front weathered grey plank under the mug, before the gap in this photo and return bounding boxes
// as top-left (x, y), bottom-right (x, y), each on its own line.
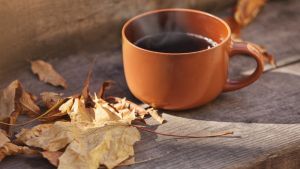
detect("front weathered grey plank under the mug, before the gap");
top-left (0, 48), bottom-right (300, 168)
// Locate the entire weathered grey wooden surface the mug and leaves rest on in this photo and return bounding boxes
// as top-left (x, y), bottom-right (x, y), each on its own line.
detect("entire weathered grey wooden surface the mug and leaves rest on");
top-left (0, 0), bottom-right (300, 169)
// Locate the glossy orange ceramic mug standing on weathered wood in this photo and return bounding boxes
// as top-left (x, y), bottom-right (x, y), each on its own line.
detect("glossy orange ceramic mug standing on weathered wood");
top-left (122, 9), bottom-right (264, 110)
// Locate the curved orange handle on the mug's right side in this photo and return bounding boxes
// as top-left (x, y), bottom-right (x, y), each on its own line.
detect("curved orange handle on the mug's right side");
top-left (223, 41), bottom-right (264, 92)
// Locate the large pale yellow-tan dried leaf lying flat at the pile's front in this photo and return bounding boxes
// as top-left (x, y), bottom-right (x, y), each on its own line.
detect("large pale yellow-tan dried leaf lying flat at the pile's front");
top-left (58, 126), bottom-right (140, 169)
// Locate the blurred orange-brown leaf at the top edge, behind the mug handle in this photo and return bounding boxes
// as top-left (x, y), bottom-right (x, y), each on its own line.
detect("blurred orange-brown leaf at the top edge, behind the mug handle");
top-left (234, 0), bottom-right (267, 27)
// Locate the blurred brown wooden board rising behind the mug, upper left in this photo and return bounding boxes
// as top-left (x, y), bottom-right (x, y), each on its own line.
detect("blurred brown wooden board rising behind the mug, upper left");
top-left (0, 0), bottom-right (234, 70)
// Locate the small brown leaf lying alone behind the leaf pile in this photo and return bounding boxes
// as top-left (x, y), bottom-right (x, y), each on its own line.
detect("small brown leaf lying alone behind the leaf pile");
top-left (31, 60), bottom-right (67, 88)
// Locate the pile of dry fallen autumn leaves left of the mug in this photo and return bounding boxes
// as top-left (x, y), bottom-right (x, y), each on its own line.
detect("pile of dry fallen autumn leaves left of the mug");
top-left (0, 60), bottom-right (232, 169)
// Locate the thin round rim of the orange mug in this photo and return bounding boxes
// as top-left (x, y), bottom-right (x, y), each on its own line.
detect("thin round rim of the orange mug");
top-left (122, 8), bottom-right (231, 55)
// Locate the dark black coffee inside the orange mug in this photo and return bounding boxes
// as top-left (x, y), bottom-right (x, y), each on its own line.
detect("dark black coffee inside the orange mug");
top-left (134, 32), bottom-right (217, 53)
